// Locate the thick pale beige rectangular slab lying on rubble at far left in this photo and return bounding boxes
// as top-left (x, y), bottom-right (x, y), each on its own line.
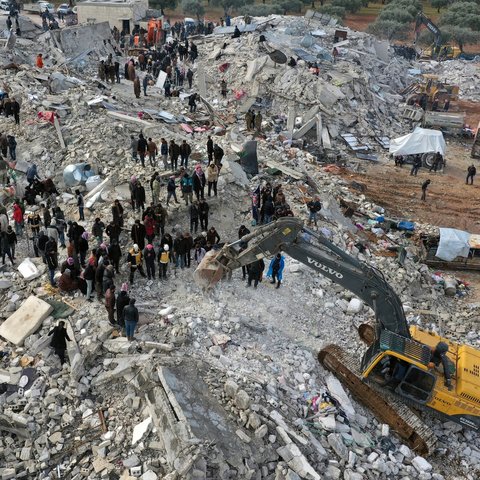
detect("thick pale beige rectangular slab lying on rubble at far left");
top-left (0, 295), bottom-right (53, 346)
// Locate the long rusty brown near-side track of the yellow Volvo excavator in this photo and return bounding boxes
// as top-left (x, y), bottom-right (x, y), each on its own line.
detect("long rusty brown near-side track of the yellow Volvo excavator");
top-left (318, 345), bottom-right (437, 455)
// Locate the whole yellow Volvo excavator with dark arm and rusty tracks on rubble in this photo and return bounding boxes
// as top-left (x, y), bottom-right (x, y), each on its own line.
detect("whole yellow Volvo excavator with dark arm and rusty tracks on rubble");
top-left (194, 217), bottom-right (480, 454)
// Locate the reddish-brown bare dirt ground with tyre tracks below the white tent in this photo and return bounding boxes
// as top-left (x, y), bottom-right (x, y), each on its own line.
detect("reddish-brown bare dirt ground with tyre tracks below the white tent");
top-left (343, 140), bottom-right (480, 233)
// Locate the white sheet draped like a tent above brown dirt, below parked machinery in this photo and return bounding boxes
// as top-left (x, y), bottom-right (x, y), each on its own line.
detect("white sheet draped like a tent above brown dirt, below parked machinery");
top-left (390, 127), bottom-right (446, 157)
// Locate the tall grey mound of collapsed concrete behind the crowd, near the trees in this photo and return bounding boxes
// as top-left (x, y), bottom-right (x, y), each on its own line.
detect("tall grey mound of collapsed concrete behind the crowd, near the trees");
top-left (199, 16), bottom-right (411, 143)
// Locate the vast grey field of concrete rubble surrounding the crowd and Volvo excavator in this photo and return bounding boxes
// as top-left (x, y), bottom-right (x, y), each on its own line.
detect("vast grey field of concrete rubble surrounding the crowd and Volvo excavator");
top-left (0, 11), bottom-right (480, 480)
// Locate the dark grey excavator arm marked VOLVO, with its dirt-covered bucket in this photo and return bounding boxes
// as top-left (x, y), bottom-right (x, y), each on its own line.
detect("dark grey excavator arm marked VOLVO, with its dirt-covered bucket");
top-left (195, 217), bottom-right (410, 338)
